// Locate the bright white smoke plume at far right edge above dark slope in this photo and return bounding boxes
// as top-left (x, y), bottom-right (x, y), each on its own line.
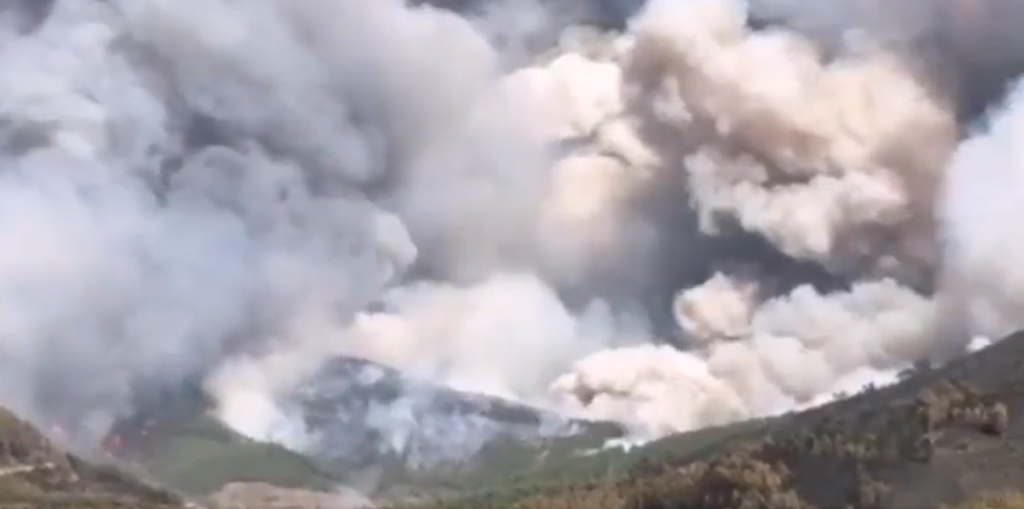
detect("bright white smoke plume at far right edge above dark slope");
top-left (937, 78), bottom-right (1024, 356)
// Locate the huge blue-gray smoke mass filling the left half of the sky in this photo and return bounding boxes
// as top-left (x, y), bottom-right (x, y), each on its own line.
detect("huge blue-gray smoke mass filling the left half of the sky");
top-left (0, 0), bottom-right (638, 450)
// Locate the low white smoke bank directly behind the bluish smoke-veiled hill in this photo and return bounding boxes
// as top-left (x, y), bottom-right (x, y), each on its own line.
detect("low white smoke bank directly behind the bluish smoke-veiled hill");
top-left (345, 273), bottom-right (646, 404)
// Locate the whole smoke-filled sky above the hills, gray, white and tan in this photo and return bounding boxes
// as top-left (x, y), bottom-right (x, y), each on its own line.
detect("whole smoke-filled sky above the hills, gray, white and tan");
top-left (0, 0), bottom-right (1024, 456)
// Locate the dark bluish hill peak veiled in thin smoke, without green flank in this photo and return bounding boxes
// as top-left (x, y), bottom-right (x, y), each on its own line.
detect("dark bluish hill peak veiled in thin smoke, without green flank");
top-left (288, 357), bottom-right (623, 484)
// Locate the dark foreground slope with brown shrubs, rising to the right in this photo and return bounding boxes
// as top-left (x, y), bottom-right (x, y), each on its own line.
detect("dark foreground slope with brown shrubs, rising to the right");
top-left (393, 333), bottom-right (1024, 509)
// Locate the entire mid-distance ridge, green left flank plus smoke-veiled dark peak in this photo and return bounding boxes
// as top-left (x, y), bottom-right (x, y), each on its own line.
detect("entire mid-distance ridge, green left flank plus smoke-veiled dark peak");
top-left (108, 358), bottom-right (622, 496)
